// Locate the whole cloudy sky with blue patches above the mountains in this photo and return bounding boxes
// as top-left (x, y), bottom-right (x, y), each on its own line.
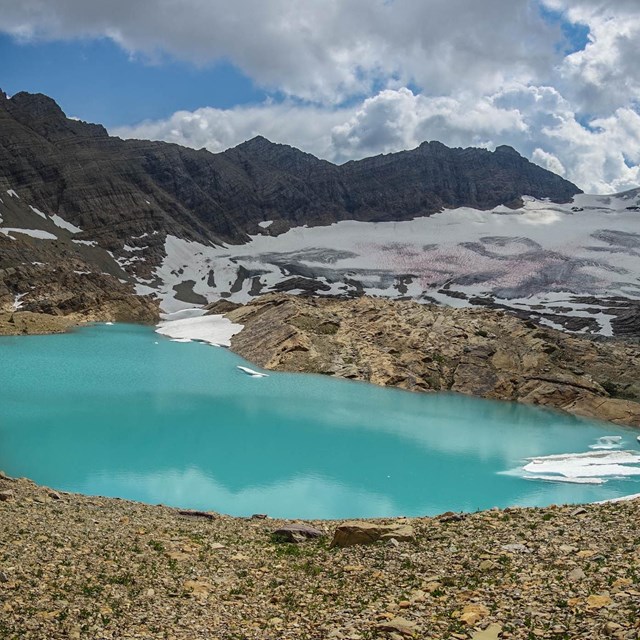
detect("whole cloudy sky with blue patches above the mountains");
top-left (0, 0), bottom-right (640, 193)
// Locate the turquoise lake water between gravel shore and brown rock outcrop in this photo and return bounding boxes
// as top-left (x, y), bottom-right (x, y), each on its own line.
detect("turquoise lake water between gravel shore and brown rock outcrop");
top-left (0, 325), bottom-right (640, 518)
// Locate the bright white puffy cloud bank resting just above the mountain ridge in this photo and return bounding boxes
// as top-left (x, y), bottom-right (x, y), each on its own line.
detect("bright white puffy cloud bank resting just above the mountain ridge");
top-left (111, 85), bottom-right (640, 193)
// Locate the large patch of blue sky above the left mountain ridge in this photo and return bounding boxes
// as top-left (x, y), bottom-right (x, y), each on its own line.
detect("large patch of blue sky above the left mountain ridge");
top-left (0, 34), bottom-right (266, 127)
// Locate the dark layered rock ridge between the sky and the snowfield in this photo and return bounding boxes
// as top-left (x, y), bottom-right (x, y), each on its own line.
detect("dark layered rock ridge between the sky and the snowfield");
top-left (0, 92), bottom-right (580, 249)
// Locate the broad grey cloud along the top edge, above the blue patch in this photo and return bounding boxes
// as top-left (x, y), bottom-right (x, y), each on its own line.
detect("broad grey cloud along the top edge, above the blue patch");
top-left (0, 0), bottom-right (561, 103)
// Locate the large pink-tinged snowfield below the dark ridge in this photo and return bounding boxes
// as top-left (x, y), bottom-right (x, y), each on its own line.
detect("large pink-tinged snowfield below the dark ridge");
top-left (148, 196), bottom-right (640, 335)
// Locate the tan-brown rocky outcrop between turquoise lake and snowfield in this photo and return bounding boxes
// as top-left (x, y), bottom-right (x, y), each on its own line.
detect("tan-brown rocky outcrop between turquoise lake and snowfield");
top-left (226, 294), bottom-right (640, 426)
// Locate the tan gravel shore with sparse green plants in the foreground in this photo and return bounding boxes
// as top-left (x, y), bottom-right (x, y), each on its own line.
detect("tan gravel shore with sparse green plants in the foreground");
top-left (0, 476), bottom-right (640, 640)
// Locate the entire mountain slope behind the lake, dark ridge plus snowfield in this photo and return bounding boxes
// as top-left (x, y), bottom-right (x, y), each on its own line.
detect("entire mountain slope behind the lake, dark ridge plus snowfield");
top-left (6, 93), bottom-right (640, 337)
